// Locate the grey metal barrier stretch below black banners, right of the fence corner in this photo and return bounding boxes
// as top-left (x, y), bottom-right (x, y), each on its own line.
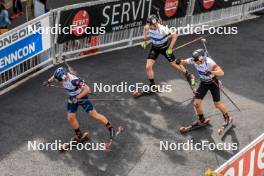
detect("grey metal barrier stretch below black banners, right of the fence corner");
top-left (56, 0), bottom-right (264, 62)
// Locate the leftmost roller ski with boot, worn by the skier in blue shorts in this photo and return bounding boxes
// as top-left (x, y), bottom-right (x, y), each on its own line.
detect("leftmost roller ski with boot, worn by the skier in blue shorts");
top-left (59, 131), bottom-right (89, 152)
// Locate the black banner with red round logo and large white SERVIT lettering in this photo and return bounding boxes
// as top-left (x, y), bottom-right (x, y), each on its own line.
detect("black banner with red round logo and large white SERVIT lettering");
top-left (57, 0), bottom-right (151, 43)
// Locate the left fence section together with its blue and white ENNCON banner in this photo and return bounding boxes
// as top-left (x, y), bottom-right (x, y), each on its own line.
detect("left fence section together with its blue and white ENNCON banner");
top-left (0, 13), bottom-right (54, 89)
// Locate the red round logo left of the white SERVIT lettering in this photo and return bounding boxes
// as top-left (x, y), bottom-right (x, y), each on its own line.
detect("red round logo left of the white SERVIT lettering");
top-left (72, 10), bottom-right (90, 37)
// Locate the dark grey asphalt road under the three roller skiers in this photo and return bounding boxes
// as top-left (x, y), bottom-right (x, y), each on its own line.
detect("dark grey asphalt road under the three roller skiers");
top-left (0, 14), bottom-right (264, 176)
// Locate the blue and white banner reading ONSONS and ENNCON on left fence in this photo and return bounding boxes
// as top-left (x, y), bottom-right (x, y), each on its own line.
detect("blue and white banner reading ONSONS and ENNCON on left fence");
top-left (0, 17), bottom-right (51, 73)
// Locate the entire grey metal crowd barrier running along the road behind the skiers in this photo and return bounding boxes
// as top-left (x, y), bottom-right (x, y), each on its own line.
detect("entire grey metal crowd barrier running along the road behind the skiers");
top-left (0, 0), bottom-right (264, 90)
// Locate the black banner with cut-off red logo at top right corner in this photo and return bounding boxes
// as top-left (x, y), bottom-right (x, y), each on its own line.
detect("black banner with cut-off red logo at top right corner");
top-left (194, 0), bottom-right (257, 14)
